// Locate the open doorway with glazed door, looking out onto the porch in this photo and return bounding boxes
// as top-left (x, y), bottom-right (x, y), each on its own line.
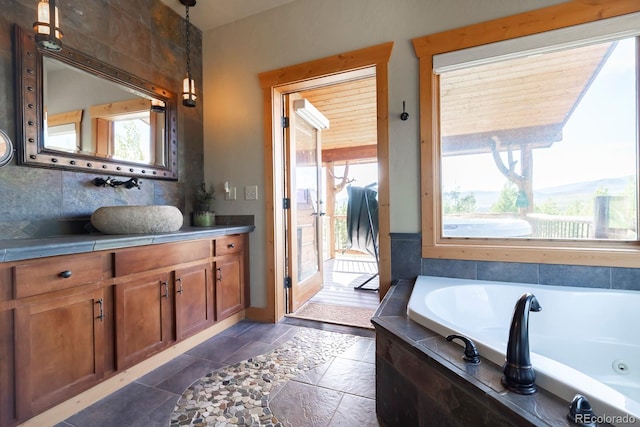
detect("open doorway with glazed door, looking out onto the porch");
top-left (283, 76), bottom-right (379, 327)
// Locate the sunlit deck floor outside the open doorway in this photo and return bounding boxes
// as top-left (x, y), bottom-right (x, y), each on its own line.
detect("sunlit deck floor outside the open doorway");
top-left (310, 257), bottom-right (380, 308)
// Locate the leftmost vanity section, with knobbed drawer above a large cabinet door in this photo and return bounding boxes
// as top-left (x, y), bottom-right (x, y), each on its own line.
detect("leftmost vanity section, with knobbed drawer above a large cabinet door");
top-left (9, 254), bottom-right (113, 420)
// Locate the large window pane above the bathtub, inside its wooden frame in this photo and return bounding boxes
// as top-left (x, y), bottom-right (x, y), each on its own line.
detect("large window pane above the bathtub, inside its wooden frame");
top-left (439, 37), bottom-right (638, 240)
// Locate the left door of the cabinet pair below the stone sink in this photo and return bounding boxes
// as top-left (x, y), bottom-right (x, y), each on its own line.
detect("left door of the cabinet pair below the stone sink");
top-left (116, 273), bottom-right (173, 369)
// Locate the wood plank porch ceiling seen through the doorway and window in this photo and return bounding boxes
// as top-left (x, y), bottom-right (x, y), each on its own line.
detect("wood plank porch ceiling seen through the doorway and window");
top-left (300, 44), bottom-right (611, 164)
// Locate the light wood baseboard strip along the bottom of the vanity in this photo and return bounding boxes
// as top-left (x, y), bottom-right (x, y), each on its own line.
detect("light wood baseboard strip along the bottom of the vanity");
top-left (20, 311), bottom-right (245, 427)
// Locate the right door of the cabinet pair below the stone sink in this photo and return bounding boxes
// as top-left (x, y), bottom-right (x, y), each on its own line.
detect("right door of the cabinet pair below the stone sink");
top-left (175, 263), bottom-right (214, 340)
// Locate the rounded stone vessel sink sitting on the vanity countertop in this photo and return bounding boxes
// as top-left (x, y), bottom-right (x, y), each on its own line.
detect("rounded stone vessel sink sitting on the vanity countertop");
top-left (91, 205), bottom-right (184, 234)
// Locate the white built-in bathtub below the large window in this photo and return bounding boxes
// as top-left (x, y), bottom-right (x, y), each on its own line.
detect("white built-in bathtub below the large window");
top-left (407, 276), bottom-right (640, 425)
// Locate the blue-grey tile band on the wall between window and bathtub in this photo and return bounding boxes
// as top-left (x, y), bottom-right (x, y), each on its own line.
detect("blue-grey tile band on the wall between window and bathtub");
top-left (391, 233), bottom-right (640, 291)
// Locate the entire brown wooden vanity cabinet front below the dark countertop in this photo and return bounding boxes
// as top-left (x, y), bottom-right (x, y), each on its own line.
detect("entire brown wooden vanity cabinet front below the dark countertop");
top-left (0, 234), bottom-right (249, 426)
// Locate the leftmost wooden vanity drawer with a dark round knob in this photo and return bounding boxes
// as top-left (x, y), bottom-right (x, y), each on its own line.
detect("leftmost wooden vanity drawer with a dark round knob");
top-left (13, 255), bottom-right (102, 298)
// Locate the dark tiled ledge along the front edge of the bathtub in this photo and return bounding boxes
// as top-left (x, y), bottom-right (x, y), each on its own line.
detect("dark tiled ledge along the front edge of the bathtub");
top-left (371, 280), bottom-right (609, 427)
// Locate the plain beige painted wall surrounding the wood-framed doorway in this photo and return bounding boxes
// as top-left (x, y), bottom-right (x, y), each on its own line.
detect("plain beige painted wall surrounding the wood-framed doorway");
top-left (203, 0), bottom-right (562, 307)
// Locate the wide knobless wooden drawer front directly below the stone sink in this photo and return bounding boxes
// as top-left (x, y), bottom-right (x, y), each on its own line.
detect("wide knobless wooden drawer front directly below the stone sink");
top-left (115, 240), bottom-right (211, 277)
